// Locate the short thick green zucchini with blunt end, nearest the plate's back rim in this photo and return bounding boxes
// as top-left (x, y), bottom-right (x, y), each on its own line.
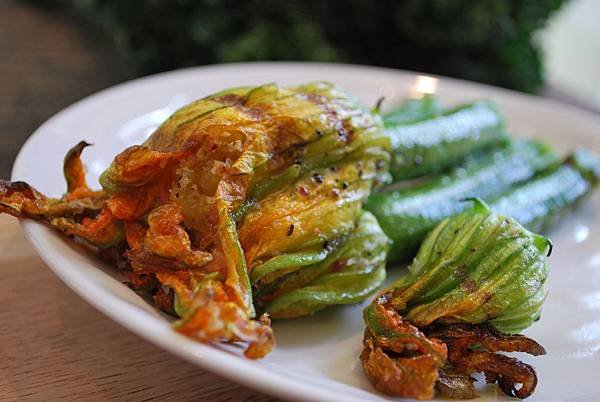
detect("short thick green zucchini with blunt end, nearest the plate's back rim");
top-left (386, 101), bottom-right (508, 181)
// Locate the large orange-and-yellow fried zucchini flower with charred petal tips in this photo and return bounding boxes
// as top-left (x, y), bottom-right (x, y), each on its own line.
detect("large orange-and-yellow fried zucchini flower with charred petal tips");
top-left (0, 83), bottom-right (390, 358)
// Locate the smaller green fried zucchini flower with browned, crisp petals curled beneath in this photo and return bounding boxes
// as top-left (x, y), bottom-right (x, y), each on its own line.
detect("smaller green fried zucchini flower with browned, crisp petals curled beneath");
top-left (361, 200), bottom-right (552, 399)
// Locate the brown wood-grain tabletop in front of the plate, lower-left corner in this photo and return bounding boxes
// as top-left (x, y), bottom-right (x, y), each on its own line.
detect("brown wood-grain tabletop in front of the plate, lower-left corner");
top-left (0, 215), bottom-right (275, 401)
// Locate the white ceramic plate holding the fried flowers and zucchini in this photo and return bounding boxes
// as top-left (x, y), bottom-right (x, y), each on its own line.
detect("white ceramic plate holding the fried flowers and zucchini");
top-left (12, 63), bottom-right (600, 401)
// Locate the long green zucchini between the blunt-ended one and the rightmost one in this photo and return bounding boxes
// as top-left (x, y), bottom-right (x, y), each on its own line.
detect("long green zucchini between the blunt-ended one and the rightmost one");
top-left (365, 140), bottom-right (559, 261)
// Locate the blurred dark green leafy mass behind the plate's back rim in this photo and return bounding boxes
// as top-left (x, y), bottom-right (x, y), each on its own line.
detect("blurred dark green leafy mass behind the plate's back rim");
top-left (38, 0), bottom-right (563, 92)
